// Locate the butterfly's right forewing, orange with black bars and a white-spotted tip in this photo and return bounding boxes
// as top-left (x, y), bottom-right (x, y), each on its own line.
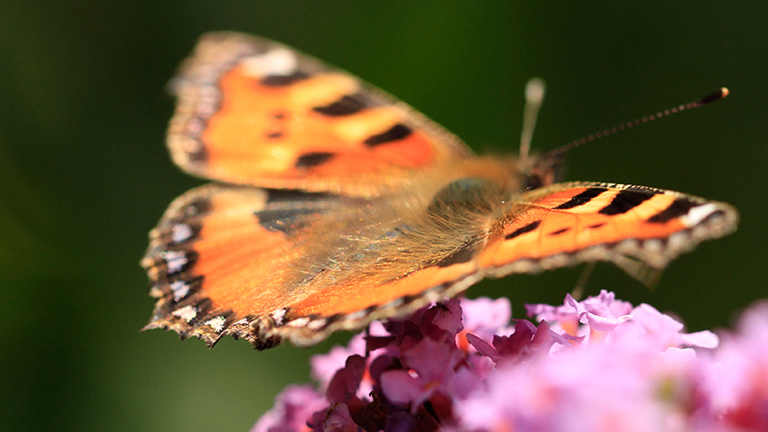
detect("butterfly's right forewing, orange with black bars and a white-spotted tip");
top-left (478, 182), bottom-right (738, 282)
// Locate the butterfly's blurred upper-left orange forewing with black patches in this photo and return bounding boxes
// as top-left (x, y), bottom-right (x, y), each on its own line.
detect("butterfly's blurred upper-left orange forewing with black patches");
top-left (168, 33), bottom-right (471, 195)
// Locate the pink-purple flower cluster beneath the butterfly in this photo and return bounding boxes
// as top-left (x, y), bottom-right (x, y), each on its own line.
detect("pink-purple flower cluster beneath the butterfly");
top-left (252, 291), bottom-right (768, 432)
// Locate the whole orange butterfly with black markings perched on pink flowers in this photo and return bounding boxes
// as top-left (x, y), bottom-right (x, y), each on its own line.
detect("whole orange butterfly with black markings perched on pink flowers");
top-left (141, 33), bottom-right (738, 349)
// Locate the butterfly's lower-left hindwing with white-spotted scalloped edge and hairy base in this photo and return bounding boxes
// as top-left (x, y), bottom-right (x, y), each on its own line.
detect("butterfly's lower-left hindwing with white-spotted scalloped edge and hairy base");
top-left (142, 177), bottom-right (492, 349)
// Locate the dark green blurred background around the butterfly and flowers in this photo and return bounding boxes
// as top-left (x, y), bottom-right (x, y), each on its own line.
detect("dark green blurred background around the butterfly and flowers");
top-left (0, 0), bottom-right (768, 431)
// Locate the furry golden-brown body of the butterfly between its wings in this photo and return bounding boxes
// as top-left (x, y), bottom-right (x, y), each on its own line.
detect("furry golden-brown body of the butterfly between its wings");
top-left (284, 158), bottom-right (524, 292)
